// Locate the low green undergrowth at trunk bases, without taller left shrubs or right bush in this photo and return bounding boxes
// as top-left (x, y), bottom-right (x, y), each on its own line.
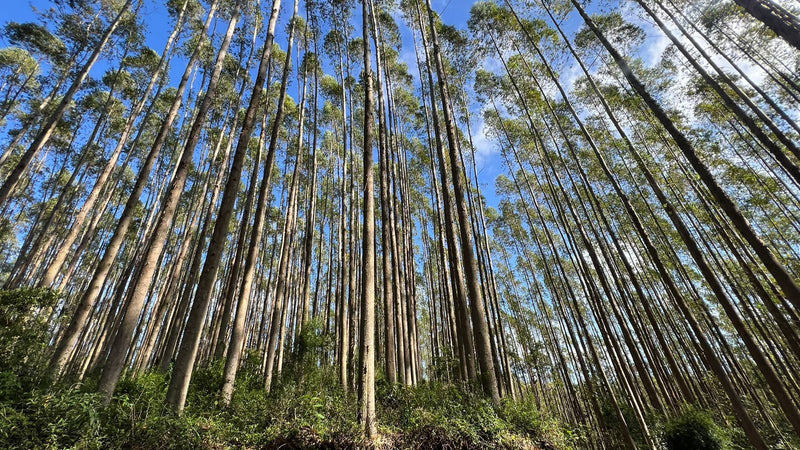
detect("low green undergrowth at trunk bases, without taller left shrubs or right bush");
top-left (0, 355), bottom-right (568, 449)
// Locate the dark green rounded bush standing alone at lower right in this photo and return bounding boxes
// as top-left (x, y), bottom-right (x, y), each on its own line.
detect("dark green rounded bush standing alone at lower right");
top-left (664, 408), bottom-right (724, 450)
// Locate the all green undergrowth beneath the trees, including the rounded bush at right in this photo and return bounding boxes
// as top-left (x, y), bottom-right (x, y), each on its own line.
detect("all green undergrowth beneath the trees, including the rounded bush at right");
top-left (0, 296), bottom-right (746, 450)
